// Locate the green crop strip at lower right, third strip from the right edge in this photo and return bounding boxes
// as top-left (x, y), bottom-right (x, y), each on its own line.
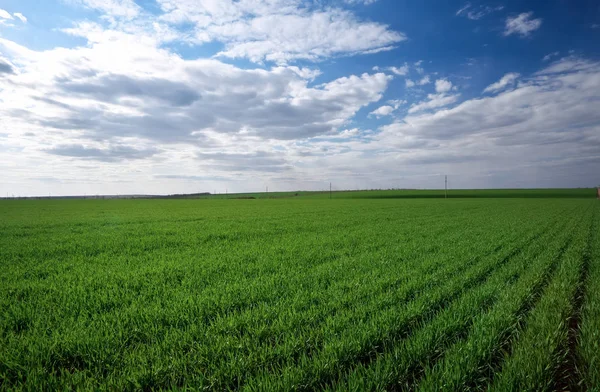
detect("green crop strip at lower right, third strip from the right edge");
top-left (412, 204), bottom-right (581, 391)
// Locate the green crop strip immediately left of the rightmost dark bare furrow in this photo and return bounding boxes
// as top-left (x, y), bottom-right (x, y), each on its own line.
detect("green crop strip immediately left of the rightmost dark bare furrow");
top-left (491, 204), bottom-right (593, 391)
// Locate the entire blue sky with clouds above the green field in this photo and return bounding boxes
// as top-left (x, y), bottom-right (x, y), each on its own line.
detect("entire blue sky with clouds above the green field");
top-left (0, 0), bottom-right (600, 196)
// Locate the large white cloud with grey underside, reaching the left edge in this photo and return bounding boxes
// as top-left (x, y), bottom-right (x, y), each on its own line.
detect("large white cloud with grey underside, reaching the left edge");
top-left (0, 34), bottom-right (391, 149)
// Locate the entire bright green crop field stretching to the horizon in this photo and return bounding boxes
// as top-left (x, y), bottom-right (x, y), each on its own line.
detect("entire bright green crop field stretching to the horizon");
top-left (0, 189), bottom-right (600, 391)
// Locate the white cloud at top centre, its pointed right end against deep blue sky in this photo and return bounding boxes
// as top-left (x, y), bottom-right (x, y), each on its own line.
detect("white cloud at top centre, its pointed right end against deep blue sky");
top-left (150, 0), bottom-right (406, 63)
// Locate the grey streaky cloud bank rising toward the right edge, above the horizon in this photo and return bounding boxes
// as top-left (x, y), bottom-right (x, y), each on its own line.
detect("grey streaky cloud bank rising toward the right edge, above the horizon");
top-left (374, 58), bottom-right (600, 190)
